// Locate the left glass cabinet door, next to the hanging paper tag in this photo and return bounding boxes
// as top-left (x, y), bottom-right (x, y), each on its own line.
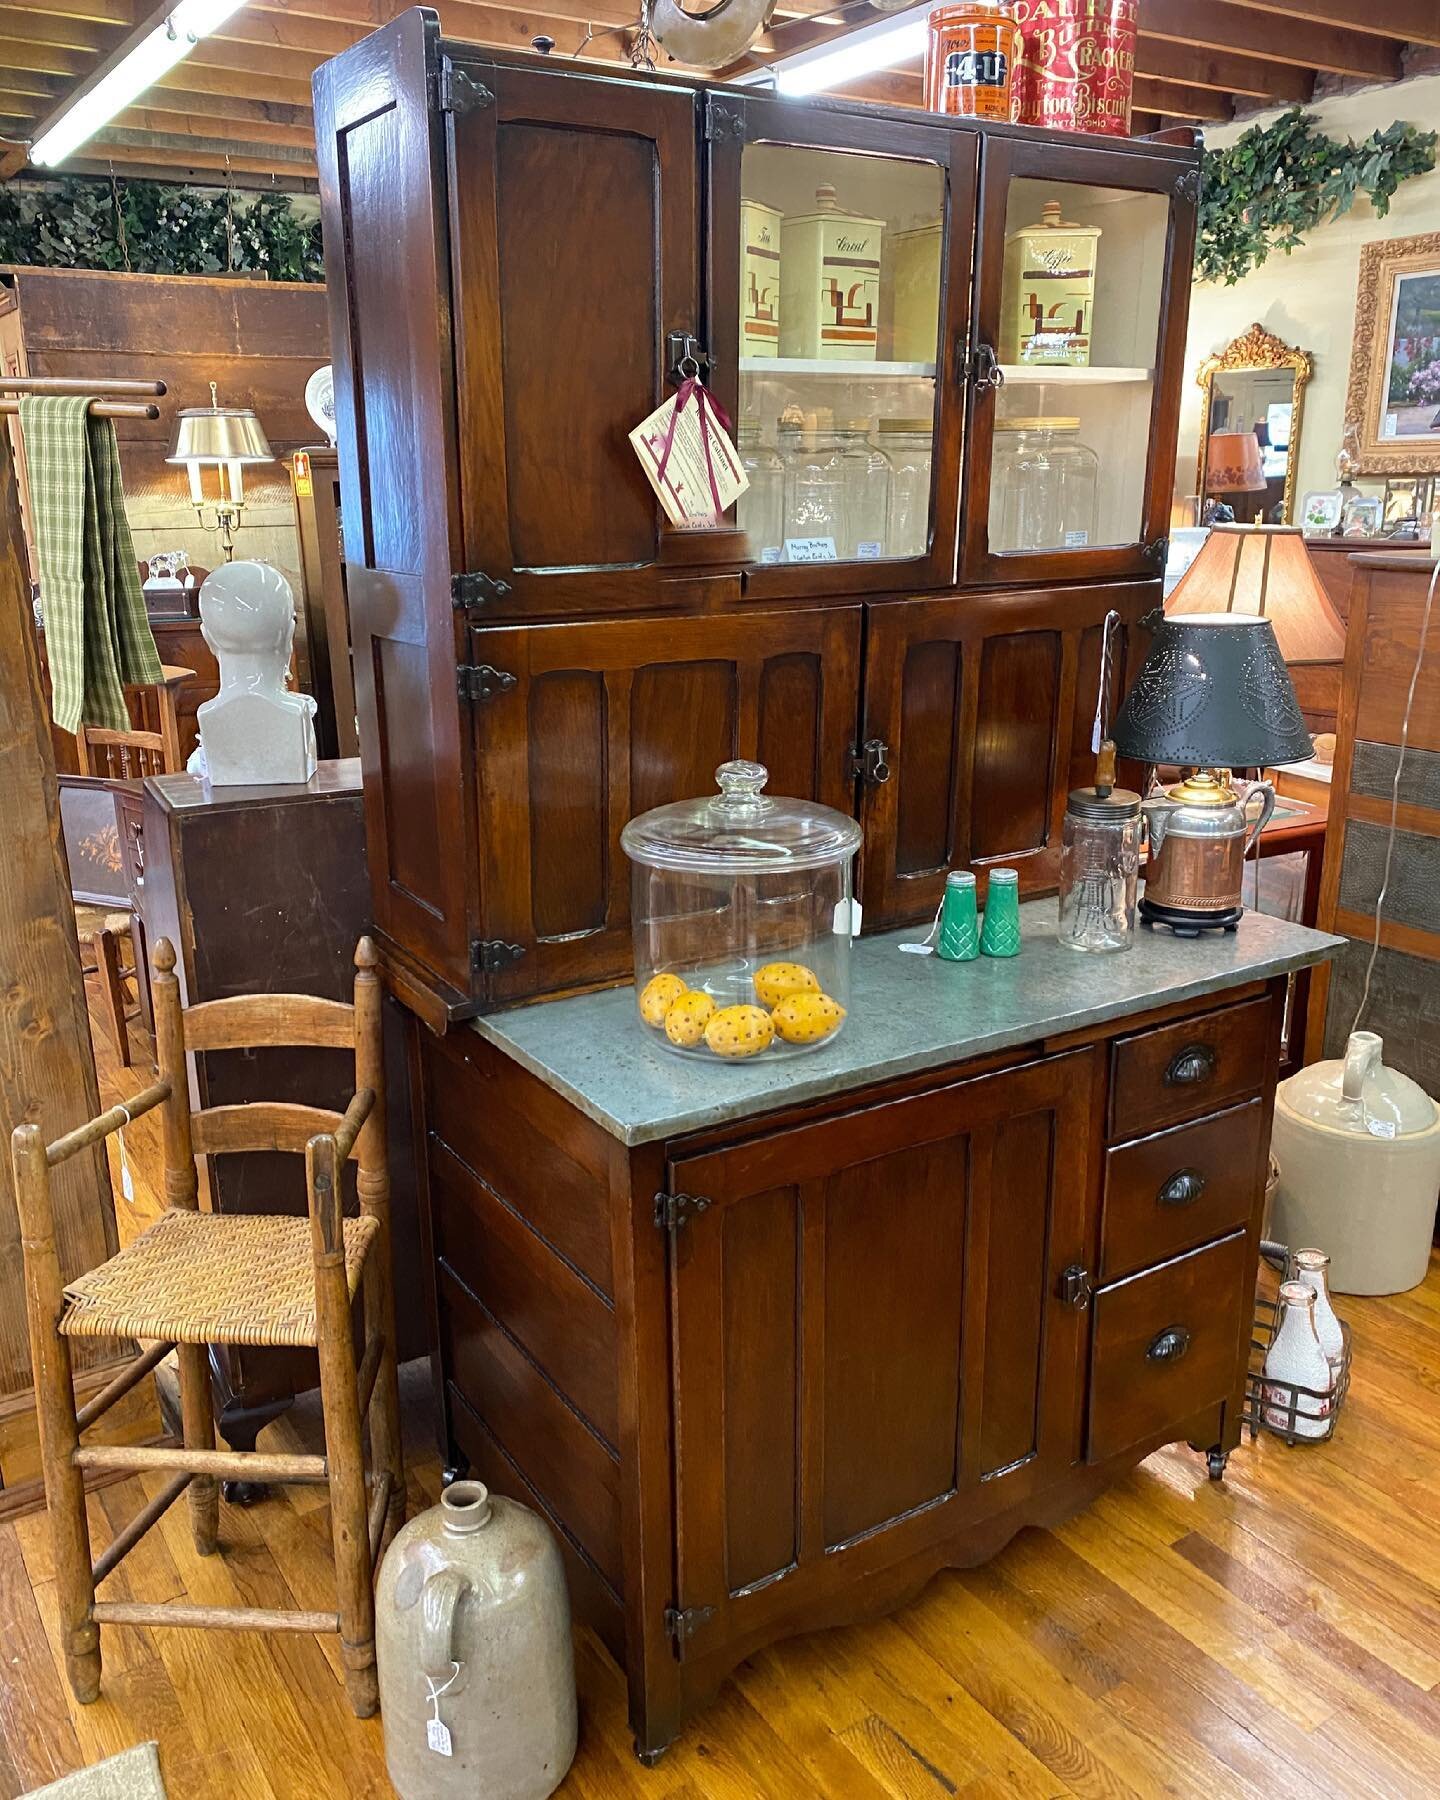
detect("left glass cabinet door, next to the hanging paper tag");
top-left (707, 95), bottom-right (976, 598)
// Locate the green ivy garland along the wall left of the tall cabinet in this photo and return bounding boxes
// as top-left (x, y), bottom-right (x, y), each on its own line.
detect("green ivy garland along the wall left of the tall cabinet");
top-left (0, 175), bottom-right (326, 281)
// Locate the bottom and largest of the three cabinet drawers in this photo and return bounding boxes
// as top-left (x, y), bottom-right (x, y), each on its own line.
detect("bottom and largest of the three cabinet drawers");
top-left (1089, 1231), bottom-right (1255, 1462)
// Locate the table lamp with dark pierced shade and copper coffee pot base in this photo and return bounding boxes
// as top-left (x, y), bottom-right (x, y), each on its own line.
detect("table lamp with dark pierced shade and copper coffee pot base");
top-left (1114, 612), bottom-right (1314, 938)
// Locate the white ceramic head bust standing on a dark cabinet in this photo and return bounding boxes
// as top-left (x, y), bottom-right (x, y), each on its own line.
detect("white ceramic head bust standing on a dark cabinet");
top-left (196, 562), bottom-right (315, 787)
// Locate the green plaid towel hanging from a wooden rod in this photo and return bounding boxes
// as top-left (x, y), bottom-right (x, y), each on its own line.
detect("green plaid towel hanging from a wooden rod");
top-left (20, 394), bottom-right (164, 731)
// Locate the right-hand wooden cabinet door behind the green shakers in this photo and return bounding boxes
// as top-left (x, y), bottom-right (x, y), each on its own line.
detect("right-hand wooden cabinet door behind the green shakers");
top-left (860, 581), bottom-right (1159, 927)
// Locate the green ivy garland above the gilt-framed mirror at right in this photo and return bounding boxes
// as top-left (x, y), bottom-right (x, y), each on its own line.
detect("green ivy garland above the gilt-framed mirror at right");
top-left (1195, 106), bottom-right (1436, 286)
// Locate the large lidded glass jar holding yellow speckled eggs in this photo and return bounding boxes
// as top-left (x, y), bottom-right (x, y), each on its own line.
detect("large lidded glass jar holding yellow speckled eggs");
top-left (621, 763), bottom-right (860, 1062)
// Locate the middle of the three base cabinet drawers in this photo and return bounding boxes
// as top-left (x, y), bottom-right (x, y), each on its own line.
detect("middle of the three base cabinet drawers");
top-left (1100, 1098), bottom-right (1265, 1282)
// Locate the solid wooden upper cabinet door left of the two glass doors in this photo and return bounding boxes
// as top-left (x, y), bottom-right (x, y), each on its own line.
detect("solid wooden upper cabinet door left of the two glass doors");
top-left (450, 63), bottom-right (716, 617)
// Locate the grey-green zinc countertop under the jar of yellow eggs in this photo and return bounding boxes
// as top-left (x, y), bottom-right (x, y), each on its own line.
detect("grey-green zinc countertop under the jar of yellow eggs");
top-left (473, 900), bottom-right (1345, 1145)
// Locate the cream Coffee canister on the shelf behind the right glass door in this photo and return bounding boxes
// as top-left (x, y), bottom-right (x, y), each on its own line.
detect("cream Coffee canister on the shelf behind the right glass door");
top-left (1001, 200), bottom-right (1100, 369)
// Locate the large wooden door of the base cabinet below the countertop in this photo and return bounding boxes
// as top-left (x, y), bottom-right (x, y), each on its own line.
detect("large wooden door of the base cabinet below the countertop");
top-left (670, 1051), bottom-right (1094, 1658)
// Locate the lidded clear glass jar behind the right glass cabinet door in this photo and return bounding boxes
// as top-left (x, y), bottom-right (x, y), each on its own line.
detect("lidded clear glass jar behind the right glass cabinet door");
top-left (990, 418), bottom-right (1100, 551)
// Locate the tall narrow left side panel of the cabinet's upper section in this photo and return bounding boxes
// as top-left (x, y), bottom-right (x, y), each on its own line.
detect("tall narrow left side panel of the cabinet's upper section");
top-left (315, 9), bottom-right (475, 997)
